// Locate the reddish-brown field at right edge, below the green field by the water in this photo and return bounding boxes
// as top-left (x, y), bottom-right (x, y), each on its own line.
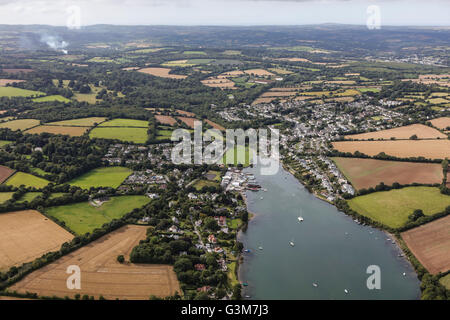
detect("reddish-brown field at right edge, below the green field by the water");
top-left (401, 216), bottom-right (450, 274)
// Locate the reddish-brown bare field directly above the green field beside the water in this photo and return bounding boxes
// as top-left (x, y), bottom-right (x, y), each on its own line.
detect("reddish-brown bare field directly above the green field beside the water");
top-left (333, 157), bottom-right (443, 190)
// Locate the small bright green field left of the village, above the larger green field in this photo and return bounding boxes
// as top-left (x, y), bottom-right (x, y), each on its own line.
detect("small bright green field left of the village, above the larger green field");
top-left (69, 167), bottom-right (133, 189)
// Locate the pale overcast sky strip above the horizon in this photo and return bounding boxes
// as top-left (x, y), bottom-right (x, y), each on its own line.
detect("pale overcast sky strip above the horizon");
top-left (0, 0), bottom-right (450, 27)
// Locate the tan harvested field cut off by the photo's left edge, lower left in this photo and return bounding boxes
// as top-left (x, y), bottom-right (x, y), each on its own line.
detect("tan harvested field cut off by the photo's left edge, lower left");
top-left (0, 210), bottom-right (73, 270)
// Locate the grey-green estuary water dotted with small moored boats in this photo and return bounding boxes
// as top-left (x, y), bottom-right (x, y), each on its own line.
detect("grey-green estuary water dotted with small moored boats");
top-left (239, 167), bottom-right (420, 300)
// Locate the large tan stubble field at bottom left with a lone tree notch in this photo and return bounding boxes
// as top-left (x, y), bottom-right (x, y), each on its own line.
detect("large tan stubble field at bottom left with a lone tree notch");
top-left (9, 225), bottom-right (181, 300)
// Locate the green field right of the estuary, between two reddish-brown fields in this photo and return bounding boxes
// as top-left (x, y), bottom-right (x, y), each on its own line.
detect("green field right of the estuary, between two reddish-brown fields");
top-left (348, 187), bottom-right (450, 228)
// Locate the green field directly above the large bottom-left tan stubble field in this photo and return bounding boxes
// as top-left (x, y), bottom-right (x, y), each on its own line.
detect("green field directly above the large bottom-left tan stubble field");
top-left (45, 196), bottom-right (150, 235)
